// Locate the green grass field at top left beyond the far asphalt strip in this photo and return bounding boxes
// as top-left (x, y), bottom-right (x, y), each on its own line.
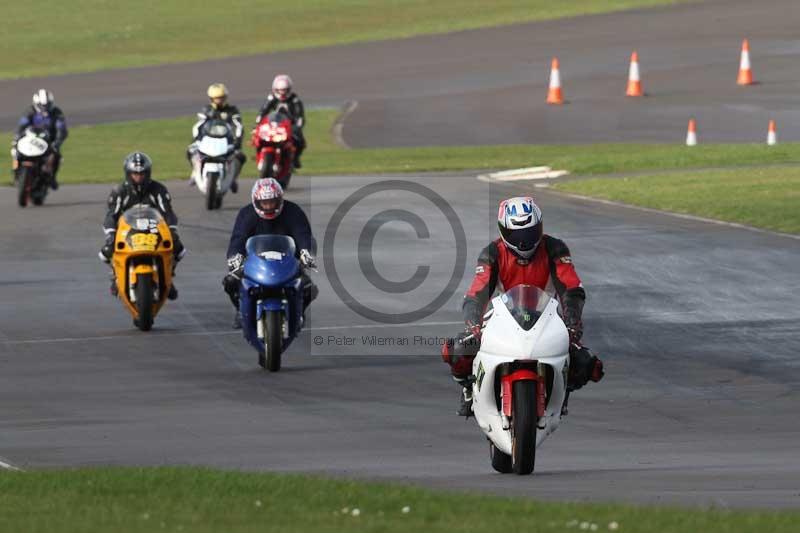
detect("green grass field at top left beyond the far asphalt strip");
top-left (0, 0), bottom-right (686, 78)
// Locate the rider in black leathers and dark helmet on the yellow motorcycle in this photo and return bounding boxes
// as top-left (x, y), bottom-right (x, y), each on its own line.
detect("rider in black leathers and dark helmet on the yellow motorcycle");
top-left (98, 152), bottom-right (186, 300)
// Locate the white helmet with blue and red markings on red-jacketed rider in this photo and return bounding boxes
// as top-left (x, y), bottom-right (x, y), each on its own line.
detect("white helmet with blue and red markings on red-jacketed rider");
top-left (497, 196), bottom-right (542, 259)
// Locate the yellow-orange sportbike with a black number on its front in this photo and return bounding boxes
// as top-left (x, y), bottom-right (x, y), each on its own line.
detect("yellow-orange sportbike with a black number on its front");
top-left (111, 205), bottom-right (175, 331)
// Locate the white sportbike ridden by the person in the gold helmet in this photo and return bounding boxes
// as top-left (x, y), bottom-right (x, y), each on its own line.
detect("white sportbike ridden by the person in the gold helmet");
top-left (192, 120), bottom-right (241, 209)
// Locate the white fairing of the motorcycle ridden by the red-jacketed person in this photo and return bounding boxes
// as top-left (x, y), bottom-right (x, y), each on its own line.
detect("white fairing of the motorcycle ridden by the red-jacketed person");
top-left (472, 289), bottom-right (569, 455)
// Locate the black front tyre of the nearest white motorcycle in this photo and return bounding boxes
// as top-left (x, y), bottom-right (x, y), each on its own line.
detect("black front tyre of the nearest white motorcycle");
top-left (511, 381), bottom-right (538, 475)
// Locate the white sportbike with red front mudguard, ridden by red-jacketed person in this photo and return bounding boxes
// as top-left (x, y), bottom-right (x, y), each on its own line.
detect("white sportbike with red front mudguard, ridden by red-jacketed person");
top-left (472, 285), bottom-right (569, 474)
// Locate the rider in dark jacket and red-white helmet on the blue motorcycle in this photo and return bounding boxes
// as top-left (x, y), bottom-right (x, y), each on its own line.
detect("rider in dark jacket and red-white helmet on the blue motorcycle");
top-left (222, 178), bottom-right (318, 329)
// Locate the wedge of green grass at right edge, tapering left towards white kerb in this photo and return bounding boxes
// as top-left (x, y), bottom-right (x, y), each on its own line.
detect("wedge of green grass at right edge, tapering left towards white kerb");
top-left (555, 167), bottom-right (800, 233)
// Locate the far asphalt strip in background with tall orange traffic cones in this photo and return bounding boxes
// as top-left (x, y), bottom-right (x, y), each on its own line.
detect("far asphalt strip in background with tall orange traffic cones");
top-left (0, 0), bottom-right (800, 145)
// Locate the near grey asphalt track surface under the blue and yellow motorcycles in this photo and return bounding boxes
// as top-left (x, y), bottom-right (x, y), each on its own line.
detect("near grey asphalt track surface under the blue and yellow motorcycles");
top-left (0, 176), bottom-right (800, 507)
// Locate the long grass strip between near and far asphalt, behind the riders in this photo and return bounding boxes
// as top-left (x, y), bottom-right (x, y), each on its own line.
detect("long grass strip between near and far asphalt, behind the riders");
top-left (0, 109), bottom-right (800, 183)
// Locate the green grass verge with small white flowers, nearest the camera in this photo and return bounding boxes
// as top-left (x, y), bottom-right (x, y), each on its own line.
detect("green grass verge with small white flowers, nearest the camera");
top-left (0, 468), bottom-right (800, 533)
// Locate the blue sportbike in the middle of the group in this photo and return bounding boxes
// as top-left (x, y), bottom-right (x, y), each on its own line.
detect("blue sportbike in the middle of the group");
top-left (239, 235), bottom-right (303, 372)
